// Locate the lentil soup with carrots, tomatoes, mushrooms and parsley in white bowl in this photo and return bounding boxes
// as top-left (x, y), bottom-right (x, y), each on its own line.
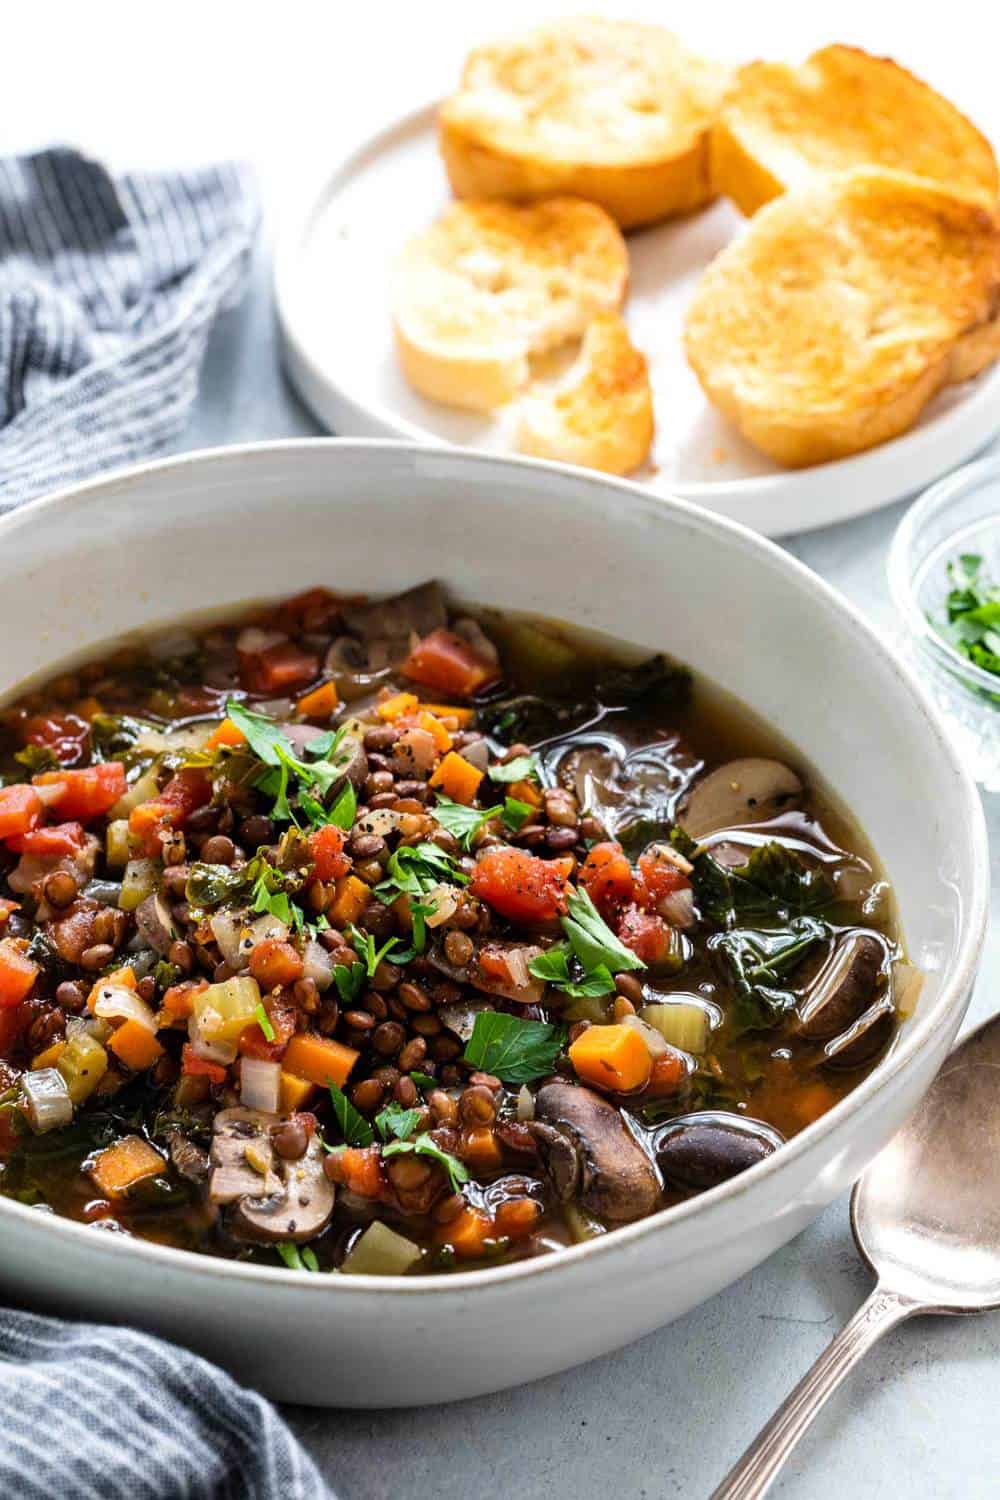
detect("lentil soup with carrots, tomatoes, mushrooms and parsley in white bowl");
top-left (0, 584), bottom-right (918, 1274)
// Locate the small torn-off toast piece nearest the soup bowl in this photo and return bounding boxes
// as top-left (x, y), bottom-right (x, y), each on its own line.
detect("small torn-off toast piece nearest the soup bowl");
top-left (517, 312), bottom-right (654, 474)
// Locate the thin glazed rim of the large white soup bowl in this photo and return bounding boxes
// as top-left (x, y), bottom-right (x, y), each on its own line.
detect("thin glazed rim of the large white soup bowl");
top-left (0, 438), bottom-right (990, 1301)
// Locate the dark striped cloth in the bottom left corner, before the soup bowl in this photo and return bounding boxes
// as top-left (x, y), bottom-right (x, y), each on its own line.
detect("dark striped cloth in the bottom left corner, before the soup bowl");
top-left (0, 1311), bottom-right (330, 1500)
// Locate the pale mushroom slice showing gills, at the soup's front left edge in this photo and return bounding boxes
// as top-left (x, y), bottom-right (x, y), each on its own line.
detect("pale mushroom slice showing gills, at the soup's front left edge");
top-left (210, 1109), bottom-right (334, 1244)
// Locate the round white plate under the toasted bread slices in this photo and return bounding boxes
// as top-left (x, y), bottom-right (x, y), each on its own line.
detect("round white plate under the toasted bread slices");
top-left (276, 107), bottom-right (1000, 536)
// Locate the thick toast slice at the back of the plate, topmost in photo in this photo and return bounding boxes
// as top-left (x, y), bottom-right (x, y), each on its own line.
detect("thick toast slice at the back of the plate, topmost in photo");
top-left (439, 18), bottom-right (729, 230)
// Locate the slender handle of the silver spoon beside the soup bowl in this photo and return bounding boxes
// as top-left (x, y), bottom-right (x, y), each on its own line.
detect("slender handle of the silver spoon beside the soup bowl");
top-left (711, 1286), bottom-right (922, 1500)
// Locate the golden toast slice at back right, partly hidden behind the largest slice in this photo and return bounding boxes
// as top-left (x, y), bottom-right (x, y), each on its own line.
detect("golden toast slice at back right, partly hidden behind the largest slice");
top-left (709, 47), bottom-right (1000, 215)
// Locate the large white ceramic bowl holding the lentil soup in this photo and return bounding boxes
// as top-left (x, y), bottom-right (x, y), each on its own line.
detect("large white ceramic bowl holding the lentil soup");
top-left (0, 441), bottom-right (990, 1407)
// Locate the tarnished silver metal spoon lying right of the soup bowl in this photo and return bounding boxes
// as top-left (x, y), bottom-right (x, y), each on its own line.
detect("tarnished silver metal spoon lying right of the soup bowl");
top-left (711, 1016), bottom-right (1000, 1500)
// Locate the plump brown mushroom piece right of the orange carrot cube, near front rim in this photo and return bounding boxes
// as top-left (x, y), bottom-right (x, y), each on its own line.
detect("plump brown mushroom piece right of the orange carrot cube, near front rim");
top-left (528, 1083), bottom-right (660, 1224)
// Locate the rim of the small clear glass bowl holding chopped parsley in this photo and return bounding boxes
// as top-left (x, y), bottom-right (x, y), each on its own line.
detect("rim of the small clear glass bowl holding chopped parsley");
top-left (886, 453), bottom-right (1000, 708)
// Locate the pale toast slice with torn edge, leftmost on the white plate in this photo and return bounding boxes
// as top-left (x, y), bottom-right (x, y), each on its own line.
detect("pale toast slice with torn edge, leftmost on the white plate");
top-left (393, 198), bottom-right (628, 411)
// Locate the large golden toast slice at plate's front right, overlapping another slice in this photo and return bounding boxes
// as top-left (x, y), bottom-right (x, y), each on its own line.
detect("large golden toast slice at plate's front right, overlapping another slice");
top-left (685, 168), bottom-right (1000, 467)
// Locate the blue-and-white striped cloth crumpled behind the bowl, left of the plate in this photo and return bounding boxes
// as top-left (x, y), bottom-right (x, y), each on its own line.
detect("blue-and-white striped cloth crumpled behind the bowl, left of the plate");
top-left (0, 149), bottom-right (258, 510)
